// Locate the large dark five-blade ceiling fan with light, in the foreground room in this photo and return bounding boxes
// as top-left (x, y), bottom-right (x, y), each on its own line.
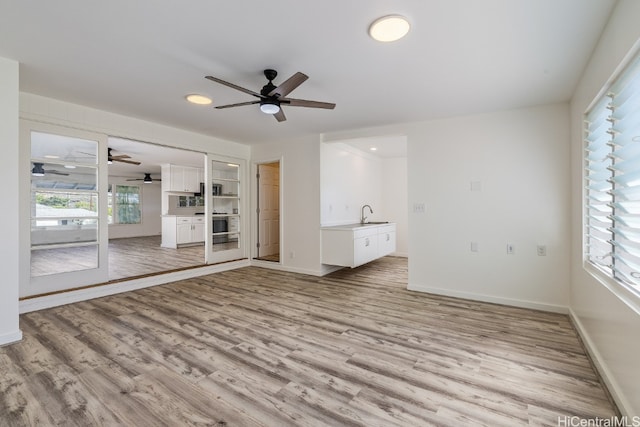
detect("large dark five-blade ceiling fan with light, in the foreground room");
top-left (205, 69), bottom-right (336, 122)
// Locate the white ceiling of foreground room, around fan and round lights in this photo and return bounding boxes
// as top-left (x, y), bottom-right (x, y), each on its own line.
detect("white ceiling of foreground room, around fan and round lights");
top-left (0, 0), bottom-right (615, 157)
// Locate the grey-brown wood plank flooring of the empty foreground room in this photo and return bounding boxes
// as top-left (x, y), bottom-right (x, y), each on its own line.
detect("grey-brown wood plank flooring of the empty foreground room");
top-left (0, 257), bottom-right (617, 426)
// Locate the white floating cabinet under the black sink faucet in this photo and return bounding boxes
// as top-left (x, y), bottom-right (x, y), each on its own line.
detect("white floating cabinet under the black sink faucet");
top-left (322, 224), bottom-right (396, 268)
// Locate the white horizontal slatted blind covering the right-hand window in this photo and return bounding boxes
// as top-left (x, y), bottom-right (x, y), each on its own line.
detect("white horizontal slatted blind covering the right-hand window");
top-left (585, 54), bottom-right (640, 290)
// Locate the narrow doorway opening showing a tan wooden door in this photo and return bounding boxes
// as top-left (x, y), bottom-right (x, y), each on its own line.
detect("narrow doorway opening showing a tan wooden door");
top-left (255, 161), bottom-right (280, 263)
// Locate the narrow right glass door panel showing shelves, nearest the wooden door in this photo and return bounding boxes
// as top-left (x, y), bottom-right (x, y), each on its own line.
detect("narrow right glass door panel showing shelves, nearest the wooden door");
top-left (209, 160), bottom-right (244, 262)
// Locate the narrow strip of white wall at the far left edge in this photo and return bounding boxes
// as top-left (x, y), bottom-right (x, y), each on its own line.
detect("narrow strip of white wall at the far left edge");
top-left (0, 58), bottom-right (22, 345)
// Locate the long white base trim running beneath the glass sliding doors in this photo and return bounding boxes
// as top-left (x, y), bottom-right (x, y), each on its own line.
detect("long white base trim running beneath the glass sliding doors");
top-left (20, 259), bottom-right (250, 314)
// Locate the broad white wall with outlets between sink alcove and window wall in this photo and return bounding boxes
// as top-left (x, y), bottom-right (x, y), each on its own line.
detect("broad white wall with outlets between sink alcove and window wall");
top-left (408, 104), bottom-right (570, 311)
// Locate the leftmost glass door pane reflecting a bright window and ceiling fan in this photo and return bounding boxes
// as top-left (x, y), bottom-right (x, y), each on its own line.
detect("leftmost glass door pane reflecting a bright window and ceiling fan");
top-left (26, 126), bottom-right (107, 294)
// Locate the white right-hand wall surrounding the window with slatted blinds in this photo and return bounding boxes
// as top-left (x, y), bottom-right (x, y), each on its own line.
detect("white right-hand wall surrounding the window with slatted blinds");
top-left (570, 0), bottom-right (640, 416)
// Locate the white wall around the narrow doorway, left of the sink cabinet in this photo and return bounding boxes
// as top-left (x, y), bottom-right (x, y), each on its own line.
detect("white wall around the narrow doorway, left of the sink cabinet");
top-left (250, 136), bottom-right (322, 275)
